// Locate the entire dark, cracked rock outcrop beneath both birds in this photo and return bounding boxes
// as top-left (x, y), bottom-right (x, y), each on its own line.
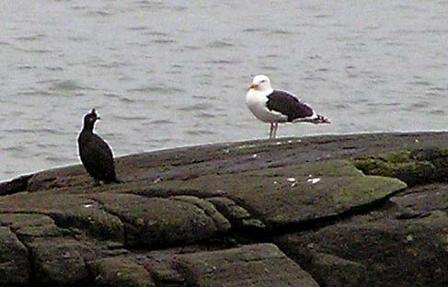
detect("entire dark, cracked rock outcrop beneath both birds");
top-left (0, 133), bottom-right (448, 286)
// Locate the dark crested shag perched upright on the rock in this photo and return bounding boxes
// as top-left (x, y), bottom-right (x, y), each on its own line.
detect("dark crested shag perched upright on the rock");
top-left (78, 109), bottom-right (119, 186)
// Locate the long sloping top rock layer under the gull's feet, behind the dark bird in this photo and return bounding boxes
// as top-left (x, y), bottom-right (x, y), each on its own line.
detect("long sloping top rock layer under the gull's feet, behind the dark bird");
top-left (14, 132), bottom-right (448, 195)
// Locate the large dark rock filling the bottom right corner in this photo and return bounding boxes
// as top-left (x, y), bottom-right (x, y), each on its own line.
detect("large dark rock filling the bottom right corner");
top-left (276, 211), bottom-right (448, 287)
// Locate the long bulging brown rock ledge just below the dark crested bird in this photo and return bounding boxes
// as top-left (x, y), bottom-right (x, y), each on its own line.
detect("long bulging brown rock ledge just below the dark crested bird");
top-left (0, 192), bottom-right (230, 251)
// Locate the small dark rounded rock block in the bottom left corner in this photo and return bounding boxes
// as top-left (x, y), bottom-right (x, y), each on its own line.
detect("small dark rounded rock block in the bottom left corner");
top-left (0, 226), bottom-right (31, 286)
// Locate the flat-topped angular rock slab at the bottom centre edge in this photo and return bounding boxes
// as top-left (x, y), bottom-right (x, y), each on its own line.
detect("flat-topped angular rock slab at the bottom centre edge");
top-left (174, 244), bottom-right (319, 287)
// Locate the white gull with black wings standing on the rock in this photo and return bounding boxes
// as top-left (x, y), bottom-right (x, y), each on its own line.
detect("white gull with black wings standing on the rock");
top-left (246, 75), bottom-right (330, 139)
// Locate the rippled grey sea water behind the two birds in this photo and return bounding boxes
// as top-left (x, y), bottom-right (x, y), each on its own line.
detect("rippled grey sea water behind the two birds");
top-left (0, 0), bottom-right (448, 180)
